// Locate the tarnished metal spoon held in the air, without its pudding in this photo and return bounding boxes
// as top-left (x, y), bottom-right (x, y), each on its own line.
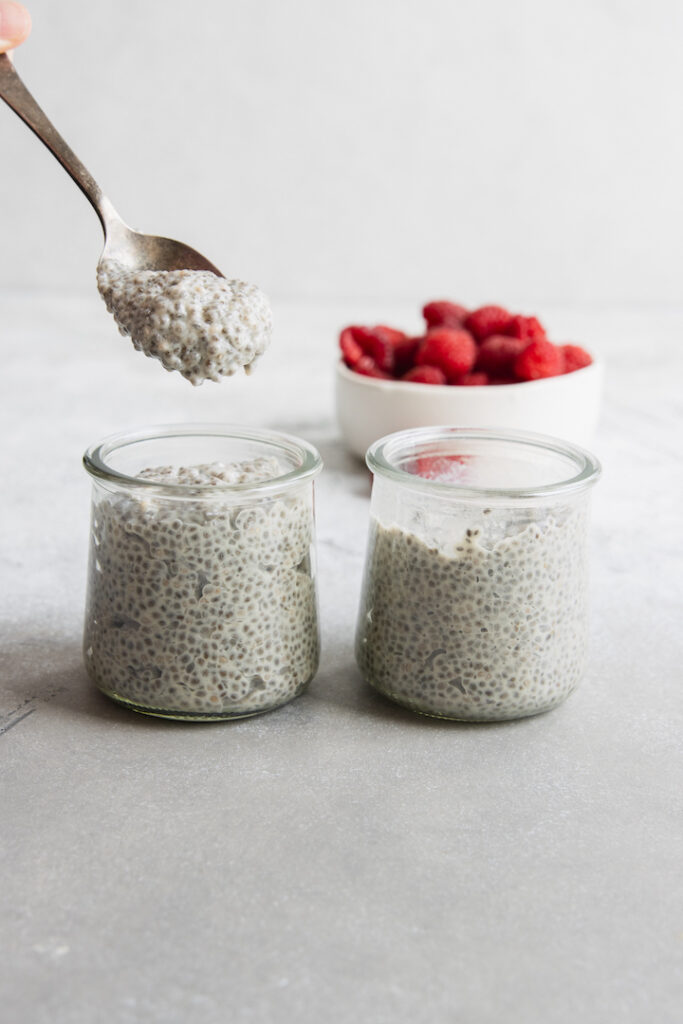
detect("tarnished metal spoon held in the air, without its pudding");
top-left (0, 53), bottom-right (223, 278)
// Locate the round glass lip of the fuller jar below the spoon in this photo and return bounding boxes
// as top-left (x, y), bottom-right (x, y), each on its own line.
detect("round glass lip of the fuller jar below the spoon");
top-left (83, 423), bottom-right (323, 499)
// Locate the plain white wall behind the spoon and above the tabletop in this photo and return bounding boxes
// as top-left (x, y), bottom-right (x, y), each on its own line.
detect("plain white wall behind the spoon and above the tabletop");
top-left (0, 0), bottom-right (683, 308)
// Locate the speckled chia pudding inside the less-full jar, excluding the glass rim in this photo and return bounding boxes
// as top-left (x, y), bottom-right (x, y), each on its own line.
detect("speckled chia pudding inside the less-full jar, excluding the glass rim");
top-left (356, 508), bottom-right (587, 721)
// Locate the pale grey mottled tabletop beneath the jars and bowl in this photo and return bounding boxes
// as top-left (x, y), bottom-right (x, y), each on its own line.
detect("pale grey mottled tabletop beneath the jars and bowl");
top-left (0, 289), bottom-right (683, 1024)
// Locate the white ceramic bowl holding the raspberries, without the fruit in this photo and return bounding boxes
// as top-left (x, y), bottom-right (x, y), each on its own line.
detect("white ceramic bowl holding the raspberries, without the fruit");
top-left (337, 359), bottom-right (604, 458)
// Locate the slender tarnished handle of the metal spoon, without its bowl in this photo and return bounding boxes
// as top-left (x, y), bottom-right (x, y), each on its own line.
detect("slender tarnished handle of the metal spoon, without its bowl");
top-left (0, 53), bottom-right (121, 233)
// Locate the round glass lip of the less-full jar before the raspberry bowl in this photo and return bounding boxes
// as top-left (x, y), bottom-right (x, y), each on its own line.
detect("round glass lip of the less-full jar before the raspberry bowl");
top-left (366, 426), bottom-right (602, 501)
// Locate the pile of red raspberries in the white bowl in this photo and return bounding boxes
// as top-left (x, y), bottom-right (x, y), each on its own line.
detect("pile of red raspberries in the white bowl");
top-left (339, 301), bottom-right (593, 387)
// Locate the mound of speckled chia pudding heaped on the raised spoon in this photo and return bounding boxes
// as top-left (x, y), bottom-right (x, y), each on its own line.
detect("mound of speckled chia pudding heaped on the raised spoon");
top-left (97, 259), bottom-right (272, 385)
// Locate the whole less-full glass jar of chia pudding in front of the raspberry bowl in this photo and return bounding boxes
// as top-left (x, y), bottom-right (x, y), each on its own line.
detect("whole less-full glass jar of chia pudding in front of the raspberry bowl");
top-left (356, 427), bottom-right (600, 722)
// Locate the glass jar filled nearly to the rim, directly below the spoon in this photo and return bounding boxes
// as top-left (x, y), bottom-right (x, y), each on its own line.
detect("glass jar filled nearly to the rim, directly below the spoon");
top-left (84, 424), bottom-right (323, 721)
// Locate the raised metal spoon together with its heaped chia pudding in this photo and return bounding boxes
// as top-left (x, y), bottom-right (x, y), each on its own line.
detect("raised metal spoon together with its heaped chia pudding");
top-left (0, 53), bottom-right (272, 384)
